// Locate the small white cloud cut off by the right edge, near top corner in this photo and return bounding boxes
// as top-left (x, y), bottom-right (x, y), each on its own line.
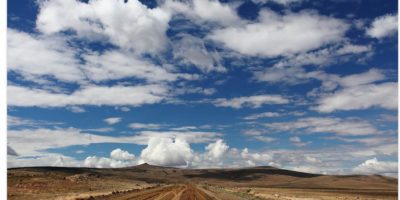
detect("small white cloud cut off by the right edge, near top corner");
top-left (366, 14), bottom-right (398, 39)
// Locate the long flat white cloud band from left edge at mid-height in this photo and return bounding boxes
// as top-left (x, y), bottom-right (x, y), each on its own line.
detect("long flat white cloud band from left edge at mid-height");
top-left (7, 85), bottom-right (168, 107)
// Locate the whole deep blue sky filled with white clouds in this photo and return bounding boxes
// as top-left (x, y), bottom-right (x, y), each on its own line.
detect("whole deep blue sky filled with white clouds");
top-left (7, 0), bottom-right (398, 176)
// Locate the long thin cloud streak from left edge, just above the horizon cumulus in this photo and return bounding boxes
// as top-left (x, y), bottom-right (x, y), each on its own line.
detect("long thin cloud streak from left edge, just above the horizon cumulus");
top-left (7, 125), bottom-right (221, 156)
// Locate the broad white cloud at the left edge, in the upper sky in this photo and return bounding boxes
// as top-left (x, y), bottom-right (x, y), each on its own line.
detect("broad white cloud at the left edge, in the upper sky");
top-left (7, 29), bottom-right (84, 82)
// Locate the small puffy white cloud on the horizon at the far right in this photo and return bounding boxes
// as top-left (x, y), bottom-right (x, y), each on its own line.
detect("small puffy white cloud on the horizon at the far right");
top-left (353, 158), bottom-right (398, 174)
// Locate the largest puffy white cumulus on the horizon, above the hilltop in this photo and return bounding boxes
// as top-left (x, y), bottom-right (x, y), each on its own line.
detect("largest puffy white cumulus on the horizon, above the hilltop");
top-left (139, 137), bottom-right (193, 166)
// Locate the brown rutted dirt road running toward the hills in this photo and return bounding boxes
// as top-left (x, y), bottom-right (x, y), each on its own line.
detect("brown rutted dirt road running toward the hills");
top-left (90, 184), bottom-right (216, 200)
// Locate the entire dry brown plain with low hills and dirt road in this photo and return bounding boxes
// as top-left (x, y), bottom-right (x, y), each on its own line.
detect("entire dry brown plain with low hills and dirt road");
top-left (8, 164), bottom-right (398, 200)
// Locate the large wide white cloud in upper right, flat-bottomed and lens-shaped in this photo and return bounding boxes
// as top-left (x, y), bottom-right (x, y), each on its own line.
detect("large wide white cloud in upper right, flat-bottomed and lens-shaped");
top-left (209, 9), bottom-right (348, 57)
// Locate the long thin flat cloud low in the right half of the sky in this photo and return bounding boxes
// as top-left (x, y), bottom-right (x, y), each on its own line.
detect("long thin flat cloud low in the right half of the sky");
top-left (264, 117), bottom-right (381, 135)
